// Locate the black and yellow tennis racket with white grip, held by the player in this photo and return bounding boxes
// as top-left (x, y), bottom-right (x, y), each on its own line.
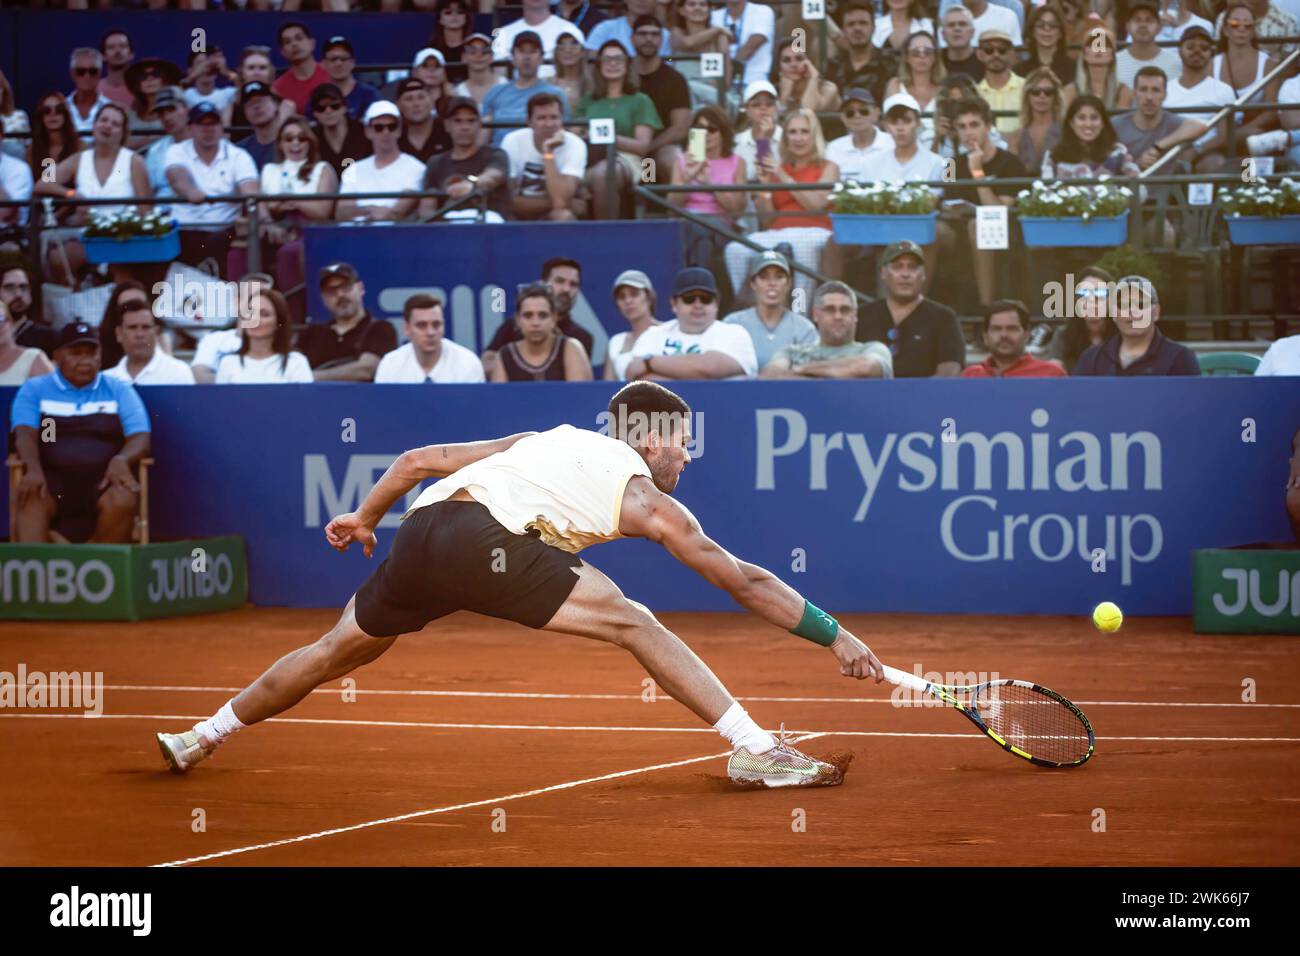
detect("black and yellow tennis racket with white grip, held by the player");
top-left (885, 665), bottom-right (1097, 767)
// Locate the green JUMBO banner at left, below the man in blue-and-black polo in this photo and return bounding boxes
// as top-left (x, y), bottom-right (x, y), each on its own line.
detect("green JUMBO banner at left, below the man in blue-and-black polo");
top-left (0, 536), bottom-right (248, 620)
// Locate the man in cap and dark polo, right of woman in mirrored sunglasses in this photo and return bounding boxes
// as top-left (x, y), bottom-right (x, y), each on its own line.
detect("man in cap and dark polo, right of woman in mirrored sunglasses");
top-left (1071, 276), bottom-right (1201, 376)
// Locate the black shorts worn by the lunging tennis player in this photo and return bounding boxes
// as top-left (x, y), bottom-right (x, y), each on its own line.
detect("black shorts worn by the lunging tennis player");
top-left (356, 501), bottom-right (582, 637)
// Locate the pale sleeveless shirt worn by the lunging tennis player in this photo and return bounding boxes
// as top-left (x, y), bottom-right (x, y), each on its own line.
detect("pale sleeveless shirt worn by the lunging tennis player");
top-left (402, 425), bottom-right (650, 554)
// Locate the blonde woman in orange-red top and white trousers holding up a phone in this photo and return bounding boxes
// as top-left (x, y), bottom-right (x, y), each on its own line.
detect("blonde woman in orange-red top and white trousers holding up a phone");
top-left (727, 109), bottom-right (840, 300)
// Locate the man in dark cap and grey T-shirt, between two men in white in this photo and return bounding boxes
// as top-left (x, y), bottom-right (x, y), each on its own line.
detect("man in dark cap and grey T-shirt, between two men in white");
top-left (420, 98), bottom-right (512, 222)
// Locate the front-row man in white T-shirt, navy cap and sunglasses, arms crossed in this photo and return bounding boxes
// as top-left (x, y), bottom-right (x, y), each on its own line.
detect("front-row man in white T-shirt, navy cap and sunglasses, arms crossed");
top-left (627, 268), bottom-right (758, 381)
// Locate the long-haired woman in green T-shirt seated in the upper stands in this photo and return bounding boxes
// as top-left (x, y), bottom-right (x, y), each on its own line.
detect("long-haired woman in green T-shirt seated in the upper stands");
top-left (579, 39), bottom-right (663, 219)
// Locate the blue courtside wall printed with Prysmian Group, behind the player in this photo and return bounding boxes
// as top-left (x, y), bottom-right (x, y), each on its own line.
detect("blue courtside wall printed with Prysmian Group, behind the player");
top-left (0, 378), bottom-right (1300, 614)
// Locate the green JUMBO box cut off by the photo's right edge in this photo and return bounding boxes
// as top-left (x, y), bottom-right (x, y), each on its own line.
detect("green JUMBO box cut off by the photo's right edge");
top-left (1192, 549), bottom-right (1300, 635)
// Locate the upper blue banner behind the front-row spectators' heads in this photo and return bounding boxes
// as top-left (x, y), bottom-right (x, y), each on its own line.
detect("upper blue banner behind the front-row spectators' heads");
top-left (303, 220), bottom-right (681, 367)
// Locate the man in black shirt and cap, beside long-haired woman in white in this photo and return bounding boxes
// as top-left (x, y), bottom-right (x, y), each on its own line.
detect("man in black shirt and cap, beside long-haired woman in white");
top-left (298, 263), bottom-right (398, 381)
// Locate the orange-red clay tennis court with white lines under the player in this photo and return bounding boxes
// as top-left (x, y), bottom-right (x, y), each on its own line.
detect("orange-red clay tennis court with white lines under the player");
top-left (0, 607), bottom-right (1300, 866)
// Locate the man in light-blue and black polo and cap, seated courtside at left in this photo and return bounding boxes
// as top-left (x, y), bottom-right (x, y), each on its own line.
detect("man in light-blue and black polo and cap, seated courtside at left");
top-left (10, 323), bottom-right (150, 544)
